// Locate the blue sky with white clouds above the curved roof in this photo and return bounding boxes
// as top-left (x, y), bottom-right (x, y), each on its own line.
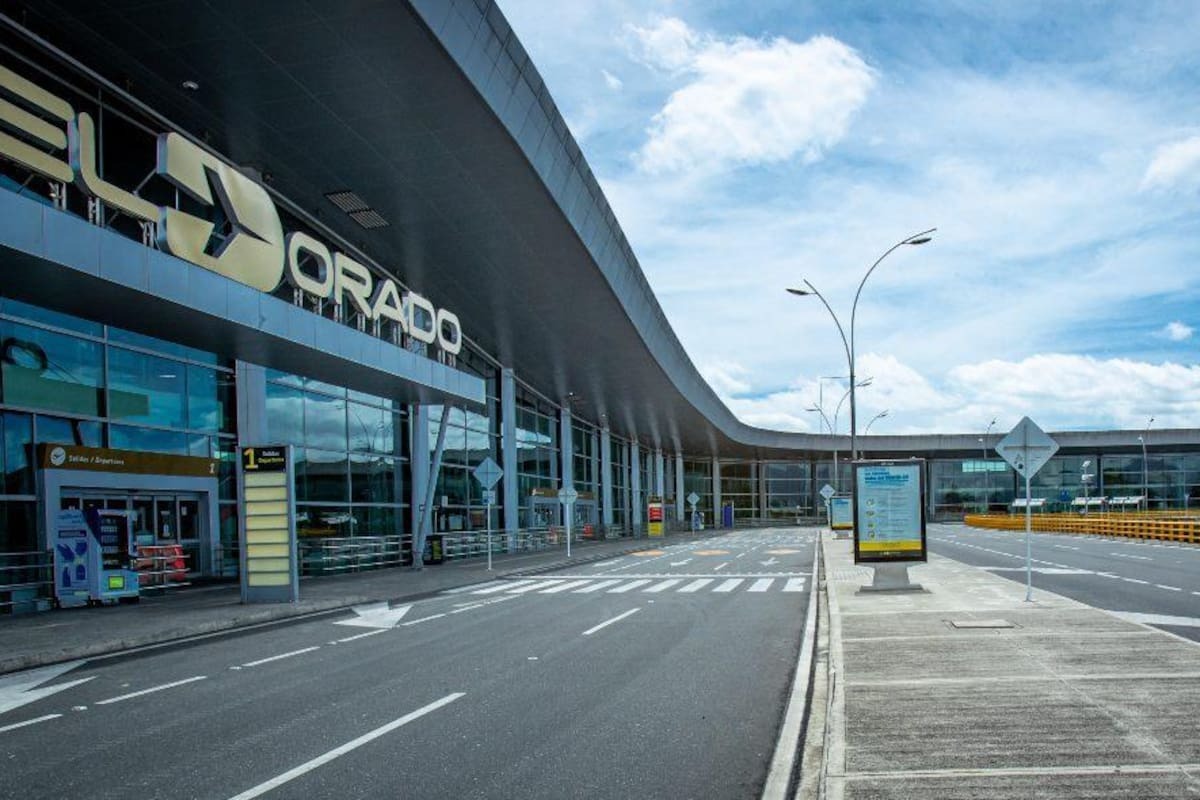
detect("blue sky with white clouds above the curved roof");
top-left (499, 0), bottom-right (1200, 434)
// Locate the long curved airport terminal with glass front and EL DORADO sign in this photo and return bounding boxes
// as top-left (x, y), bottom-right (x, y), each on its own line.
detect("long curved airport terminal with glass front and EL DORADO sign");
top-left (0, 0), bottom-right (1200, 613)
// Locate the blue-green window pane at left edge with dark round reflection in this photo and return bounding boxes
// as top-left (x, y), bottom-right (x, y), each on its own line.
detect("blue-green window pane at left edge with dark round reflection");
top-left (0, 321), bottom-right (103, 416)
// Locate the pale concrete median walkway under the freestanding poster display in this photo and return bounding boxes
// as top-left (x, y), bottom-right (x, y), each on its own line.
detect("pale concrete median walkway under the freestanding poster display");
top-left (810, 537), bottom-right (1200, 800)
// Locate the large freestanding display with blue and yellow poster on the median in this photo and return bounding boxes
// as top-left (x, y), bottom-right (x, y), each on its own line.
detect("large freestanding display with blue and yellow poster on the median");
top-left (854, 458), bottom-right (925, 564)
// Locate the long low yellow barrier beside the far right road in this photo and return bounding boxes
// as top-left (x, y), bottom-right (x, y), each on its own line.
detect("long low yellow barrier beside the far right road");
top-left (964, 511), bottom-right (1200, 545)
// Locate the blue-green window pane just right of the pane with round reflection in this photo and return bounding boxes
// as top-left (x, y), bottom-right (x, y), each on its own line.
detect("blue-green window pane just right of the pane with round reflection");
top-left (108, 348), bottom-right (186, 428)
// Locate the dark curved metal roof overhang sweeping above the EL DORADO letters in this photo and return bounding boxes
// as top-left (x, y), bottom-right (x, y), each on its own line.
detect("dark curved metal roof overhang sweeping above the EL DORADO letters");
top-left (10, 0), bottom-right (1190, 458)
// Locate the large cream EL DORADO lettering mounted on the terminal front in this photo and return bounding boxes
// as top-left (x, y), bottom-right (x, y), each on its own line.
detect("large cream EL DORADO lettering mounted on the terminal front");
top-left (0, 66), bottom-right (462, 356)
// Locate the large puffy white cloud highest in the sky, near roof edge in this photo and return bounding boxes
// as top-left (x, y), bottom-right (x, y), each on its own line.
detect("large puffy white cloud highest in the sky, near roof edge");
top-left (630, 18), bottom-right (875, 174)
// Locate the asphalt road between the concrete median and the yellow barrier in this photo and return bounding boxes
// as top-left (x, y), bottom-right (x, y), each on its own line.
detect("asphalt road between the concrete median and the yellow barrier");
top-left (928, 525), bottom-right (1200, 642)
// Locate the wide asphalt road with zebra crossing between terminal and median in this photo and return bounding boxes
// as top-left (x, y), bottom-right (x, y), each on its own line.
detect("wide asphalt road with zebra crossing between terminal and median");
top-left (0, 529), bottom-right (814, 800)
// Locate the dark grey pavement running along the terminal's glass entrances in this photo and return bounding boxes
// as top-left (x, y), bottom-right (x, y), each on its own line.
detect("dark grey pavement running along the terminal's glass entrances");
top-left (0, 534), bottom-right (686, 674)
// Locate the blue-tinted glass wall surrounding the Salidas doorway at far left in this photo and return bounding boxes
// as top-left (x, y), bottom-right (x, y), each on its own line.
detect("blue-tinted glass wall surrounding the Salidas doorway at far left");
top-left (0, 297), bottom-right (238, 563)
